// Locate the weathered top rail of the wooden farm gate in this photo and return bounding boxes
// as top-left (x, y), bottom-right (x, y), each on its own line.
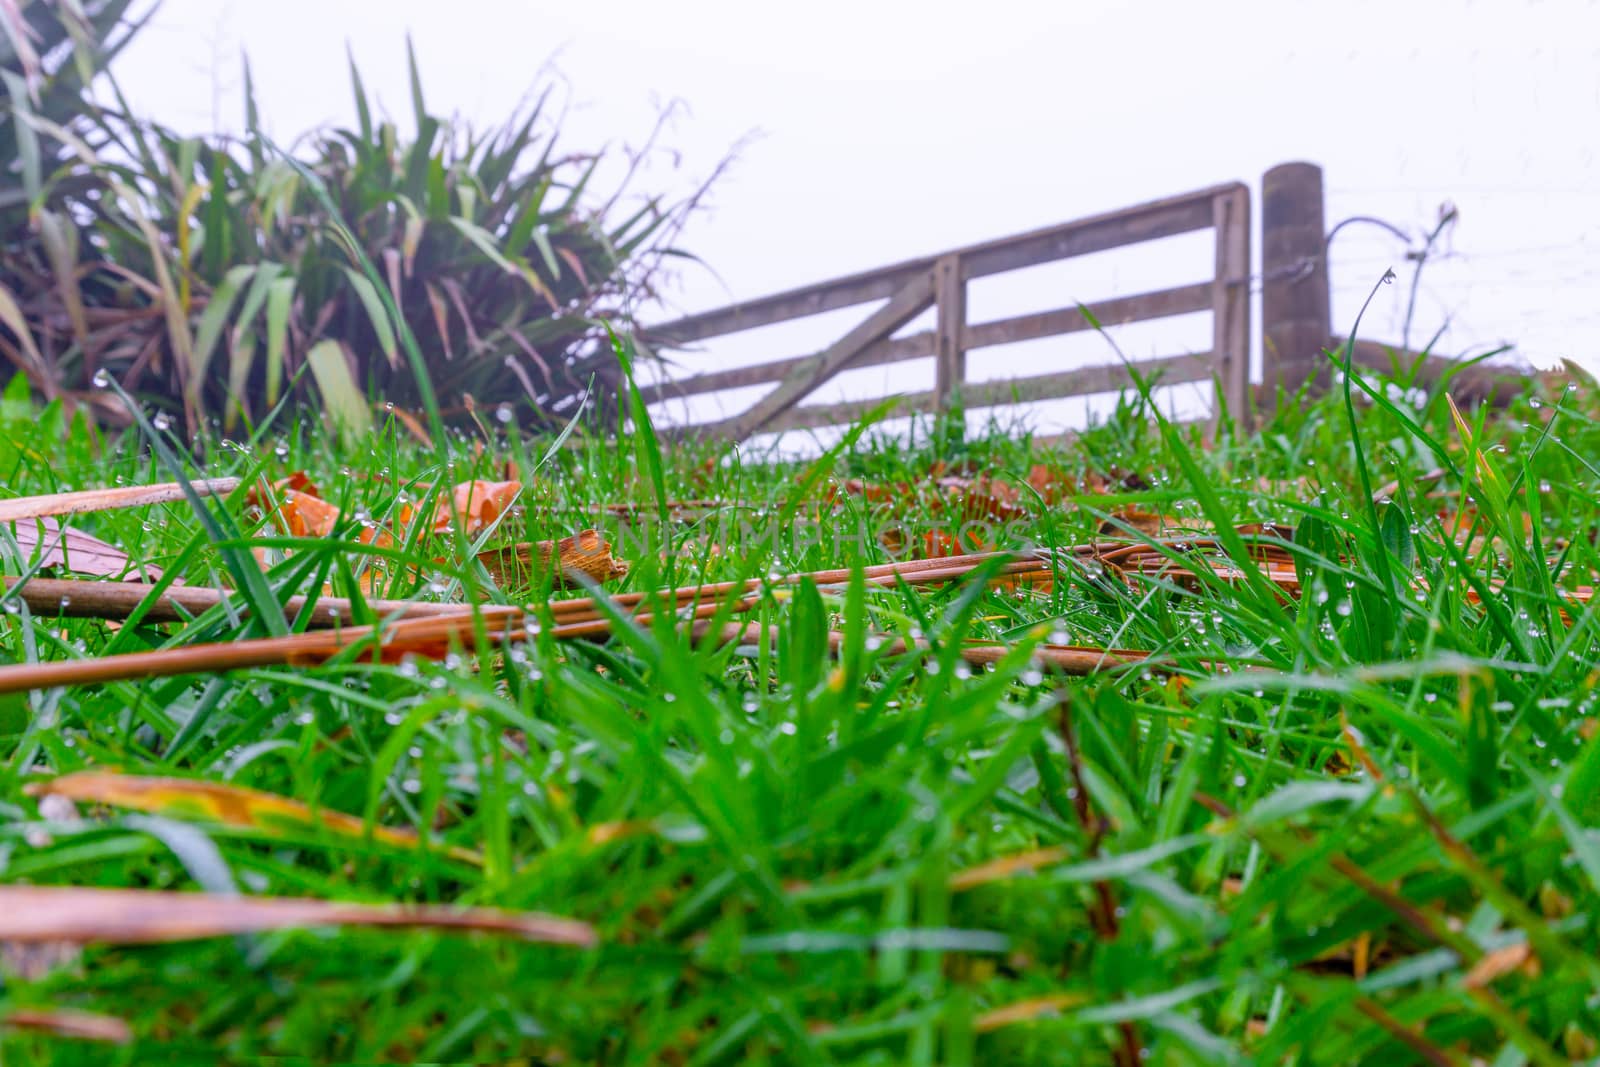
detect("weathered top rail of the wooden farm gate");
top-left (642, 182), bottom-right (1243, 346)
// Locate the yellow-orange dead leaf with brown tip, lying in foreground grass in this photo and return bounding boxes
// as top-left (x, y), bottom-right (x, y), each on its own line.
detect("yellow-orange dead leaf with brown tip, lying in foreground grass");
top-left (24, 771), bottom-right (483, 865)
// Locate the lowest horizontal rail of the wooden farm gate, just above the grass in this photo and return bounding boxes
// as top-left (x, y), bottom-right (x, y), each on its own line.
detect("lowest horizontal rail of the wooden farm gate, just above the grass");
top-left (766, 352), bottom-right (1213, 432)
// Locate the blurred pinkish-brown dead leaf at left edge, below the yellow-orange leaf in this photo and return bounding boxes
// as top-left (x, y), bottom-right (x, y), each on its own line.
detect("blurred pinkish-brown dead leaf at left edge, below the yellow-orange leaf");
top-left (0, 886), bottom-right (597, 949)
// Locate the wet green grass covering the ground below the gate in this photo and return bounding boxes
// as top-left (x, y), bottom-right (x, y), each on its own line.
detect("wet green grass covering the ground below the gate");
top-left (0, 351), bottom-right (1600, 1067)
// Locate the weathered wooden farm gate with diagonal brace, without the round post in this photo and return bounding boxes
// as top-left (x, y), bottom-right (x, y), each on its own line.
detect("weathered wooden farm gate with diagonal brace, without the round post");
top-left (640, 182), bottom-right (1251, 440)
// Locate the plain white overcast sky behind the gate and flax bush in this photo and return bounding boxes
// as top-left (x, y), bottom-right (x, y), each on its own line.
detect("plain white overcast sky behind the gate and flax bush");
top-left (117, 0), bottom-right (1600, 435)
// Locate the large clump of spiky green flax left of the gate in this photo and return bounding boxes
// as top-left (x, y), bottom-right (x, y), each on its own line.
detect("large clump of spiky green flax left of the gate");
top-left (0, 0), bottom-right (698, 430)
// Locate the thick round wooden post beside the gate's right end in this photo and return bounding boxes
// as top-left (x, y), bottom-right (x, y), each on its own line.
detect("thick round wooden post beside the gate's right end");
top-left (1261, 163), bottom-right (1333, 410)
